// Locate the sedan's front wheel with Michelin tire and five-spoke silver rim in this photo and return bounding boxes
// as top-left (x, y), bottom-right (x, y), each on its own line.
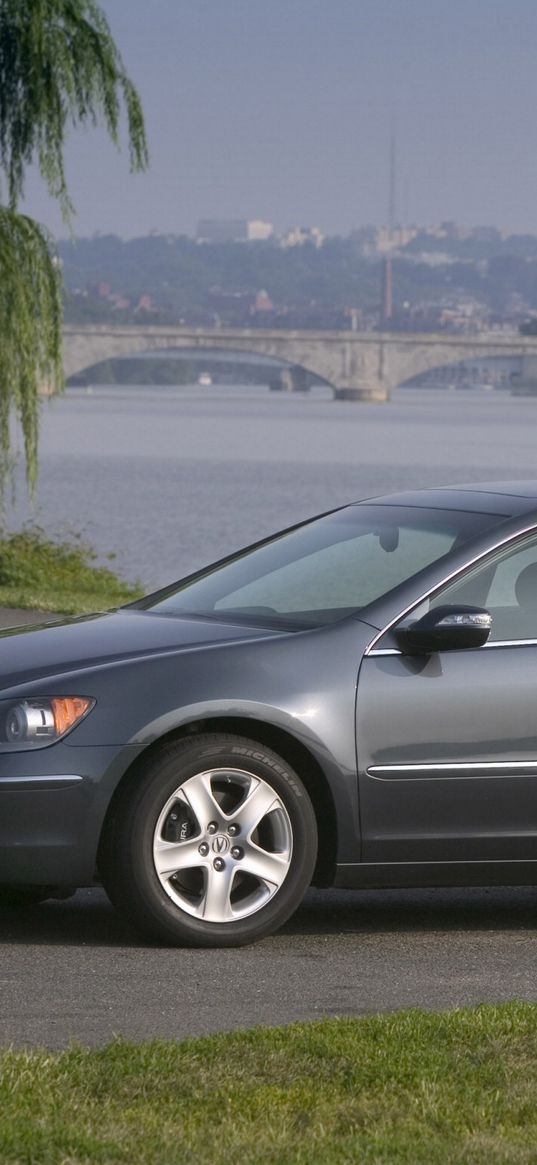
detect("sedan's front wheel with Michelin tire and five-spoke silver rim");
top-left (99, 734), bottom-right (317, 947)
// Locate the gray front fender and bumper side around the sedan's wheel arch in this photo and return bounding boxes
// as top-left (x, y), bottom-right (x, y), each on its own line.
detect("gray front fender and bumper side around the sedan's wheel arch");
top-left (0, 614), bottom-right (372, 884)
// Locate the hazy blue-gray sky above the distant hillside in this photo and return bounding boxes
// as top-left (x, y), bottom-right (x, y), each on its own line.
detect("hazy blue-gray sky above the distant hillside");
top-left (19, 0), bottom-right (537, 238)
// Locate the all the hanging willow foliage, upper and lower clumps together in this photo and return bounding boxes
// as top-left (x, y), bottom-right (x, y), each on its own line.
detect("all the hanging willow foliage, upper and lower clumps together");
top-left (0, 0), bottom-right (148, 494)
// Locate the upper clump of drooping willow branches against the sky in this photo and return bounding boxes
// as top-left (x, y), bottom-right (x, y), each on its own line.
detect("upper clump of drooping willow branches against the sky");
top-left (0, 0), bottom-right (148, 218)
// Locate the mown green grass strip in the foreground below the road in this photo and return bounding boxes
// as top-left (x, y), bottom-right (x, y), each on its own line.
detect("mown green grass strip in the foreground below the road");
top-left (0, 1001), bottom-right (537, 1165)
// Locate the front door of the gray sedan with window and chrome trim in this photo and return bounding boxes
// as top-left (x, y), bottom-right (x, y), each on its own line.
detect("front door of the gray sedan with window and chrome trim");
top-left (356, 534), bottom-right (537, 862)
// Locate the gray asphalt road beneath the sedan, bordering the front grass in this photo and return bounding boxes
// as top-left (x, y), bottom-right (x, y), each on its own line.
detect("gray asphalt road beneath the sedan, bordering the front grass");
top-left (0, 888), bottom-right (537, 1047)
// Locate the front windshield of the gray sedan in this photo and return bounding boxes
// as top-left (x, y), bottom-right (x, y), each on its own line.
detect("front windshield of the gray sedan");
top-left (136, 504), bottom-right (502, 629)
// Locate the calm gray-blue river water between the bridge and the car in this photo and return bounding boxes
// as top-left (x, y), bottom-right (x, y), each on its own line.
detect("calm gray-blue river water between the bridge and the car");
top-left (6, 386), bottom-right (537, 588)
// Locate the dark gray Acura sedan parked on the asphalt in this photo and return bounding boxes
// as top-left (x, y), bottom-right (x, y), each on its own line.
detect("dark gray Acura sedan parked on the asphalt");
top-left (0, 482), bottom-right (537, 946)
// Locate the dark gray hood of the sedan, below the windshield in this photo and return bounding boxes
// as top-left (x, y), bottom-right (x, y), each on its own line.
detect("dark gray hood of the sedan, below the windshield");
top-left (0, 610), bottom-right (282, 690)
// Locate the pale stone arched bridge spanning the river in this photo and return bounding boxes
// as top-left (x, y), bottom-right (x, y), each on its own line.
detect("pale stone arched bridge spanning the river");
top-left (64, 325), bottom-right (537, 401)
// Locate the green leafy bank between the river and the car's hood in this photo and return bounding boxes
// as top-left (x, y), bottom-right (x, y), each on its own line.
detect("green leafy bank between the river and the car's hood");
top-left (0, 525), bottom-right (141, 615)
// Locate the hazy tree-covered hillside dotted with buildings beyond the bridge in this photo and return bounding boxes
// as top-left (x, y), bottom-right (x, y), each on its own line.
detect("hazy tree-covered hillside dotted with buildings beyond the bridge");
top-left (58, 228), bottom-right (537, 330)
